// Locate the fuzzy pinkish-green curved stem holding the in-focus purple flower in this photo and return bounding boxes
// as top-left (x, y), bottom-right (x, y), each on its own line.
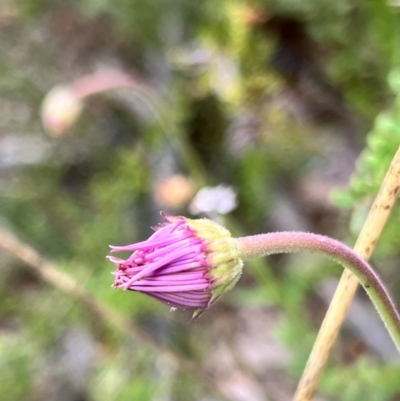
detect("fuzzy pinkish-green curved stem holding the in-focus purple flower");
top-left (238, 231), bottom-right (400, 352)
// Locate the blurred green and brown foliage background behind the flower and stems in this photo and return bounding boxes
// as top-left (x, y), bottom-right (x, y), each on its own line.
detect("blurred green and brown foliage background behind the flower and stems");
top-left (0, 0), bottom-right (400, 401)
